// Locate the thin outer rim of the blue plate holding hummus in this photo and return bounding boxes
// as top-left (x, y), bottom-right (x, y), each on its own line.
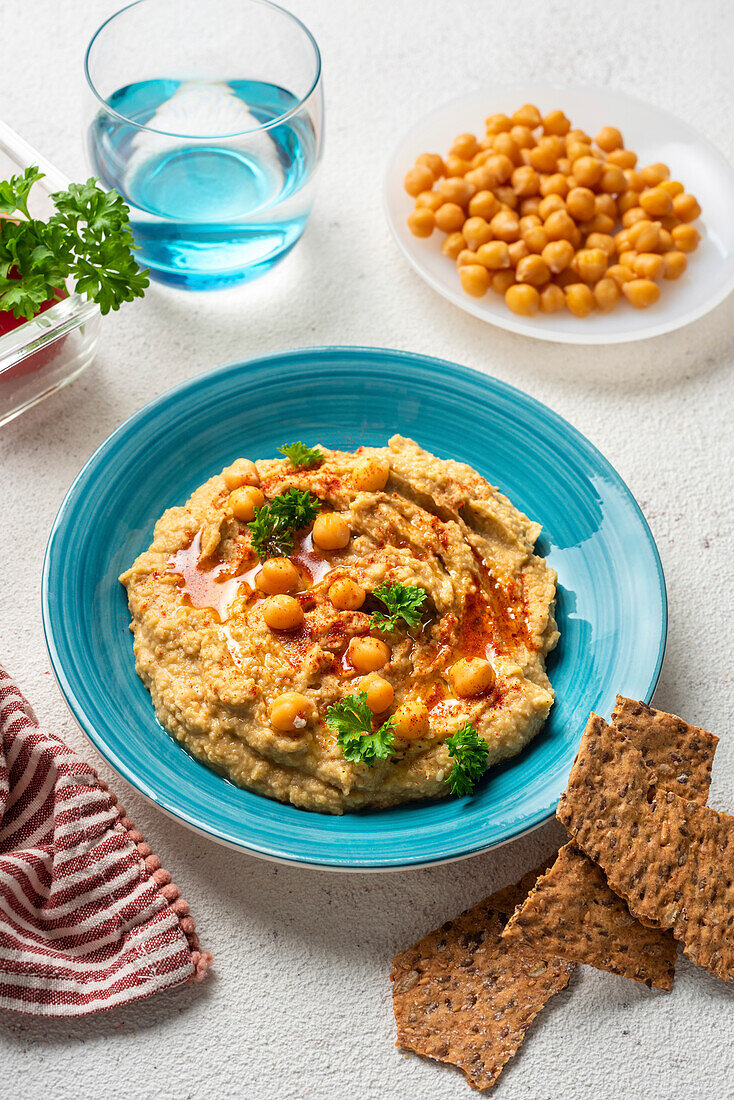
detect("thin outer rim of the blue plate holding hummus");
top-left (41, 344), bottom-right (669, 872)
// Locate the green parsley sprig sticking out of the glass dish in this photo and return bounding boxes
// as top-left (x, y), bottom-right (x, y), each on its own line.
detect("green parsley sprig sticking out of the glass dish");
top-left (0, 165), bottom-right (149, 320)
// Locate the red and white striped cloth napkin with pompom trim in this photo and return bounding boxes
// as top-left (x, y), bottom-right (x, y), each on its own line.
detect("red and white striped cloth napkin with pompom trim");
top-left (0, 668), bottom-right (211, 1016)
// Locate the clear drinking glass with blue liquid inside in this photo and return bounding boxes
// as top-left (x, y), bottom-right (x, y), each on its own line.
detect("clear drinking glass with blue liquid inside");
top-left (86, 0), bottom-right (324, 289)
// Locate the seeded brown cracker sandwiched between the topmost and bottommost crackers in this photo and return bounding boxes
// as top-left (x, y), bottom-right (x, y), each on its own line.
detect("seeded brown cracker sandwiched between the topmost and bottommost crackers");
top-left (503, 695), bottom-right (717, 989)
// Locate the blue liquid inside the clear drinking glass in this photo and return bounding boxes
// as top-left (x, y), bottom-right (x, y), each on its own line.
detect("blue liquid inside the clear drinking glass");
top-left (88, 80), bottom-right (318, 289)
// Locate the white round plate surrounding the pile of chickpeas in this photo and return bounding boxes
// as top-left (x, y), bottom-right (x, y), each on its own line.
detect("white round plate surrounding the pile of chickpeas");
top-left (384, 84), bottom-right (734, 344)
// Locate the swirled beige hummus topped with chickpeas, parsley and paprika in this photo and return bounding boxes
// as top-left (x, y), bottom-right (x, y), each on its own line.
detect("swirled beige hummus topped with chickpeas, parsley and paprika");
top-left (120, 436), bottom-right (558, 814)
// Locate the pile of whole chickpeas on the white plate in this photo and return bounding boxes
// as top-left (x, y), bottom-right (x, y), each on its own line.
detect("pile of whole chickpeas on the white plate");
top-left (405, 103), bottom-right (701, 317)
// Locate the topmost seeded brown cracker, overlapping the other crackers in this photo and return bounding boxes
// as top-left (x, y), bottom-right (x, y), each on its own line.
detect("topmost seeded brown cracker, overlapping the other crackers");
top-left (558, 715), bottom-right (734, 981)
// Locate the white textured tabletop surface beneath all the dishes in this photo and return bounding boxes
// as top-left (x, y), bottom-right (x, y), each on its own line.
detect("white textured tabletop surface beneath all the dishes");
top-left (0, 0), bottom-right (734, 1100)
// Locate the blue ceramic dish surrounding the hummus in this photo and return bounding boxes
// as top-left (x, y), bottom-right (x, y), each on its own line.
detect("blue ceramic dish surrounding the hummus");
top-left (43, 348), bottom-right (667, 870)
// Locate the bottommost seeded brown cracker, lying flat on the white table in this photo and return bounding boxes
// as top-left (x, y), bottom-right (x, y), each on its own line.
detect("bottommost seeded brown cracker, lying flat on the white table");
top-left (391, 865), bottom-right (573, 1090)
